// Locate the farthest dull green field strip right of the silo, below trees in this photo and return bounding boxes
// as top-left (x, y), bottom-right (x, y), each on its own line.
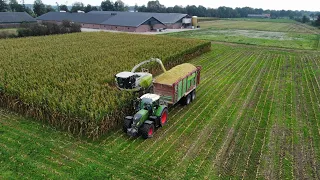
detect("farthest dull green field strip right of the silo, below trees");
top-left (199, 20), bottom-right (320, 34)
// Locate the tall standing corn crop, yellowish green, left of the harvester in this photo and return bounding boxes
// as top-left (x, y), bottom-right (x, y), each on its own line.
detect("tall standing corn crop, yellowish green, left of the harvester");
top-left (0, 32), bottom-right (211, 138)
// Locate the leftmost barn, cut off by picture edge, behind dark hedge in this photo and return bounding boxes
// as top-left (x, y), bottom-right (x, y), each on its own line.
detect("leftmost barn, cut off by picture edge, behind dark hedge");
top-left (0, 12), bottom-right (37, 28)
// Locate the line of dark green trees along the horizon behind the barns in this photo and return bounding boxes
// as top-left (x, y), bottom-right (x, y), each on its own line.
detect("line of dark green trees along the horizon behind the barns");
top-left (0, 0), bottom-right (320, 19)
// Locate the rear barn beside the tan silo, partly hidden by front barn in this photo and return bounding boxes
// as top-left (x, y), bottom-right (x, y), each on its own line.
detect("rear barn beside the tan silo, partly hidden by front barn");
top-left (89, 11), bottom-right (191, 29)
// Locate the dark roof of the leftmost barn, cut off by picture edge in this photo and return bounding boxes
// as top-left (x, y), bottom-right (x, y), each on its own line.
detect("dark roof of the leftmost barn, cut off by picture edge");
top-left (0, 12), bottom-right (36, 23)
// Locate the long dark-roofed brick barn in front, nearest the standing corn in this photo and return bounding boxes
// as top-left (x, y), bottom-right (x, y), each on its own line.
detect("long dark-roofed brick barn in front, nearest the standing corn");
top-left (37, 12), bottom-right (165, 32)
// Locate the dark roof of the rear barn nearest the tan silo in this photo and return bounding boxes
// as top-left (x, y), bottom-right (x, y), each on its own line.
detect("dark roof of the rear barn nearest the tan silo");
top-left (89, 11), bottom-right (188, 24)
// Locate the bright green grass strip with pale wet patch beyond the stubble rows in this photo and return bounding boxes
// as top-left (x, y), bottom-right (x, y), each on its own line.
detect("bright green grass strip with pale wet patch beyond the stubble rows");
top-left (166, 28), bottom-right (320, 50)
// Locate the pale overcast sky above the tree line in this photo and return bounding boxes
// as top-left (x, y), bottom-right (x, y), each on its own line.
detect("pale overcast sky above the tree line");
top-left (20, 0), bottom-right (320, 11)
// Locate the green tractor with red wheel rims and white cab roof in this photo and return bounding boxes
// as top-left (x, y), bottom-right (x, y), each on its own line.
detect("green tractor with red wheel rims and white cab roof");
top-left (123, 93), bottom-right (168, 139)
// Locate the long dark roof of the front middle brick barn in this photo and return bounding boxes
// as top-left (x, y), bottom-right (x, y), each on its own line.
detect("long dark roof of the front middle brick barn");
top-left (37, 12), bottom-right (162, 27)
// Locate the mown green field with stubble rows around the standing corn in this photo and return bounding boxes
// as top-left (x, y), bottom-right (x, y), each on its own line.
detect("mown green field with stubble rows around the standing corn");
top-left (0, 44), bottom-right (320, 179)
